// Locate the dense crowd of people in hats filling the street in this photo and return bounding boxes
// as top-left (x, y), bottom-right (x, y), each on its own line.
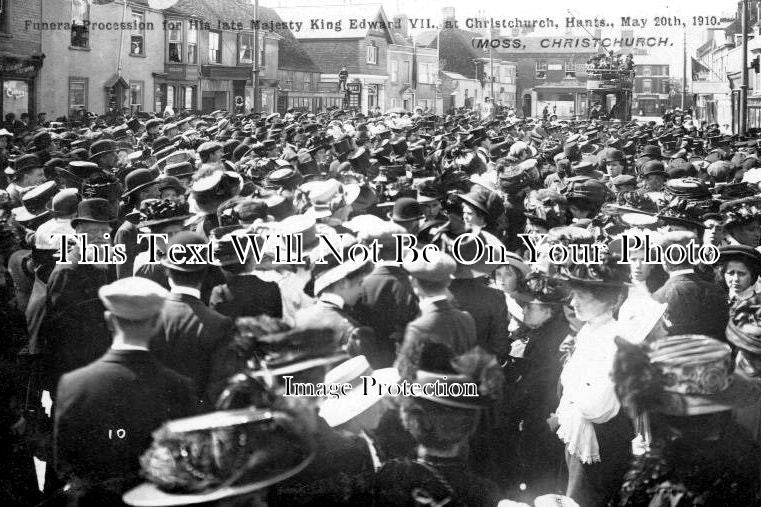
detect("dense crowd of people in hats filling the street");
top-left (0, 104), bottom-right (761, 507)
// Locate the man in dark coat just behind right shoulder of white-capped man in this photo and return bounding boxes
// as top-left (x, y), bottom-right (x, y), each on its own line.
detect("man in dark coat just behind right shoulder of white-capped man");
top-left (151, 231), bottom-right (233, 410)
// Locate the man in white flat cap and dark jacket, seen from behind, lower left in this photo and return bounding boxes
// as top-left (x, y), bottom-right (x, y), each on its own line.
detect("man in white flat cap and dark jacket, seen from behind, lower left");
top-left (54, 278), bottom-right (195, 500)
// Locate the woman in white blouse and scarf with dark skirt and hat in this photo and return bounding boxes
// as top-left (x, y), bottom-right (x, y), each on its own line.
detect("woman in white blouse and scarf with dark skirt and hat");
top-left (551, 256), bottom-right (634, 507)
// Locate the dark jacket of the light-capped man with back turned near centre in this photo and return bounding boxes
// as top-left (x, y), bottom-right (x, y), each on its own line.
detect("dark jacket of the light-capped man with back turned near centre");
top-left (397, 299), bottom-right (476, 379)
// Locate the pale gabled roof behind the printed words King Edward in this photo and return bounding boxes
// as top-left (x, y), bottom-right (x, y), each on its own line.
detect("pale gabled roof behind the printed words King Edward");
top-left (275, 4), bottom-right (394, 43)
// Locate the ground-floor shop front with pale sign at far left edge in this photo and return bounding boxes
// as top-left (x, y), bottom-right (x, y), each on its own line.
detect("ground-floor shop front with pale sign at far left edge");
top-left (0, 56), bottom-right (42, 118)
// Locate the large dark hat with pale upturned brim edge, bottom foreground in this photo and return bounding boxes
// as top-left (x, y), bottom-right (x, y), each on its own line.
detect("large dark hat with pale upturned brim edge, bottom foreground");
top-left (123, 407), bottom-right (314, 507)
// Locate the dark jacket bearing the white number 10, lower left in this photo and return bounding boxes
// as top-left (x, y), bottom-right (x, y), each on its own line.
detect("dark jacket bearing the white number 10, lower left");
top-left (55, 350), bottom-right (196, 487)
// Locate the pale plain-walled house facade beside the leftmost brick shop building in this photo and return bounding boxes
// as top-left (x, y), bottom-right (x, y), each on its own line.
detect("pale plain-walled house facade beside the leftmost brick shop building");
top-left (40, 0), bottom-right (164, 119)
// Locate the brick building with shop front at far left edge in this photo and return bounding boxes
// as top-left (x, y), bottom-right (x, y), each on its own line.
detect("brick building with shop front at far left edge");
top-left (0, 0), bottom-right (44, 120)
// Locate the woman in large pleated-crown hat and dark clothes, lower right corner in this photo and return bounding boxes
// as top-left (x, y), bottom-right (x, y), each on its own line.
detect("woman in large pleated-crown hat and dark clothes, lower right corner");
top-left (613, 336), bottom-right (761, 507)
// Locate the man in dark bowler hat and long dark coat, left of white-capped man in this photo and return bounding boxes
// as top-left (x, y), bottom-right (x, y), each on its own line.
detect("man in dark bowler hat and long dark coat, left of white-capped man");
top-left (40, 198), bottom-right (113, 392)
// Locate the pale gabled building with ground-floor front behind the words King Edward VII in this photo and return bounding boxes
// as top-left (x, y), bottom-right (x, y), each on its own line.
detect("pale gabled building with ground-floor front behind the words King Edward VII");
top-left (275, 4), bottom-right (395, 111)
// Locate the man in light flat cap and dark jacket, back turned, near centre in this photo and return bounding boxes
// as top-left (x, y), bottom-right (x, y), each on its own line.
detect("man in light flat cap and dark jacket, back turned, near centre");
top-left (396, 251), bottom-right (476, 378)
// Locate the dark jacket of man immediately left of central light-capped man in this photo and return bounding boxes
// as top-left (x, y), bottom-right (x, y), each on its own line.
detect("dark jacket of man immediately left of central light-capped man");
top-left (355, 266), bottom-right (418, 368)
